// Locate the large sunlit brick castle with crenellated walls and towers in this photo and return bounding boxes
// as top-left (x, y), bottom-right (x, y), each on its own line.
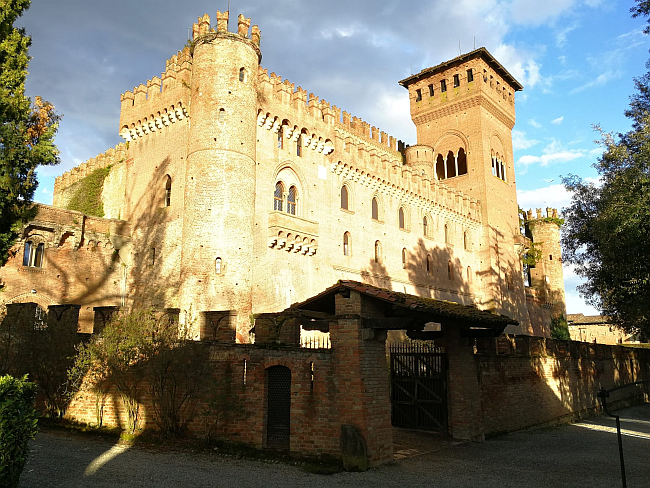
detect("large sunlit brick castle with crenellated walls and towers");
top-left (0, 12), bottom-right (565, 342)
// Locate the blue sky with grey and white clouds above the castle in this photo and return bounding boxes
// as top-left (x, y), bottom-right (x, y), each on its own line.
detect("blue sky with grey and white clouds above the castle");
top-left (18, 0), bottom-right (650, 314)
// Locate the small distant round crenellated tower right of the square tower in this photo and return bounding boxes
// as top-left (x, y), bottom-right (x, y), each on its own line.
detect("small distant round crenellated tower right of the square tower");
top-left (526, 207), bottom-right (566, 315)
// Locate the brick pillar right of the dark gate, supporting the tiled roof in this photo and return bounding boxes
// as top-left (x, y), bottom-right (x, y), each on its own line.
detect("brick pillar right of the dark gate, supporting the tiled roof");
top-left (442, 324), bottom-right (485, 441)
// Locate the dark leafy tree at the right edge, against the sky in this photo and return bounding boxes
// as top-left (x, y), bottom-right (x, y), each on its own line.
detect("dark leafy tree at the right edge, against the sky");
top-left (562, 0), bottom-right (650, 336)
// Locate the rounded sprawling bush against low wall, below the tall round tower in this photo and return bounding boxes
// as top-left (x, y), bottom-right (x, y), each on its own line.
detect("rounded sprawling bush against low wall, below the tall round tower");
top-left (69, 309), bottom-right (211, 436)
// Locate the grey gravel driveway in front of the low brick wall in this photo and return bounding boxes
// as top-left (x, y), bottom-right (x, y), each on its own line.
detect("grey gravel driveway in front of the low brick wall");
top-left (21, 404), bottom-right (650, 488)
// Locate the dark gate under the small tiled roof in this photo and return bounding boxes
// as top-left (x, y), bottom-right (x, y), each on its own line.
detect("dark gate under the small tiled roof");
top-left (389, 343), bottom-right (447, 434)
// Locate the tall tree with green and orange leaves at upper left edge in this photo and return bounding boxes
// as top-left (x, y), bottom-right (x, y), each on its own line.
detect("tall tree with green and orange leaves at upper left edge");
top-left (0, 0), bottom-right (59, 265)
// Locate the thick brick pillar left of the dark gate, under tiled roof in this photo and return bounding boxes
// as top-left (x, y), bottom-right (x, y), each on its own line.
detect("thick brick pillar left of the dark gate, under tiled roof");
top-left (330, 291), bottom-right (393, 466)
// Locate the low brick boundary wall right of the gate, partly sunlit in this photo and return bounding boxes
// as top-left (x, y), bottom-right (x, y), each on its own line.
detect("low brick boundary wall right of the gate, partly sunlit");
top-left (475, 336), bottom-right (650, 434)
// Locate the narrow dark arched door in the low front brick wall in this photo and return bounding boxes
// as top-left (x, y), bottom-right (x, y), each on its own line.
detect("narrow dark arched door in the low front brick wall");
top-left (266, 366), bottom-right (291, 450)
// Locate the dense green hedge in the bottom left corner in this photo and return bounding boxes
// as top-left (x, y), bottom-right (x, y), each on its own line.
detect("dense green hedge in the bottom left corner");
top-left (0, 376), bottom-right (38, 488)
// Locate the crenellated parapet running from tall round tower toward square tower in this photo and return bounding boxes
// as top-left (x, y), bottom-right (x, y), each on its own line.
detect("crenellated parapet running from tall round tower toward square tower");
top-left (257, 67), bottom-right (404, 152)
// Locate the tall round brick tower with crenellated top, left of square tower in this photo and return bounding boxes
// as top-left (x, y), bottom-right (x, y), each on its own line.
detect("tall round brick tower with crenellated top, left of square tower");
top-left (181, 12), bottom-right (261, 342)
